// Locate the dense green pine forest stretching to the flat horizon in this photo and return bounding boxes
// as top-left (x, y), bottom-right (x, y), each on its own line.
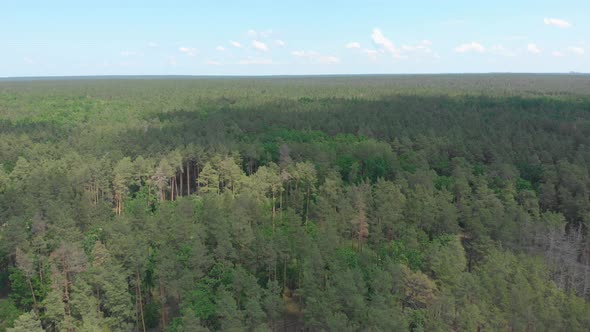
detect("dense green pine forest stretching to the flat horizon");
top-left (0, 74), bottom-right (590, 332)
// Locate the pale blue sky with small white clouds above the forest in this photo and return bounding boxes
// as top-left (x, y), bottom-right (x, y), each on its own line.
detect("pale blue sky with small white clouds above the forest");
top-left (0, 0), bottom-right (590, 77)
